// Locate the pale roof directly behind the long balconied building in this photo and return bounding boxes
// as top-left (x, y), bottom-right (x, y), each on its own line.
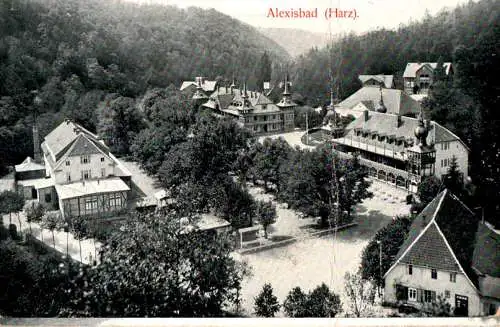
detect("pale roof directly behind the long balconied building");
top-left (338, 86), bottom-right (420, 115)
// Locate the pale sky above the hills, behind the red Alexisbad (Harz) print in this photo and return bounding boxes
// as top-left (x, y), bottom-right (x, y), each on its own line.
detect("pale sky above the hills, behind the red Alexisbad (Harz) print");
top-left (127, 0), bottom-right (468, 34)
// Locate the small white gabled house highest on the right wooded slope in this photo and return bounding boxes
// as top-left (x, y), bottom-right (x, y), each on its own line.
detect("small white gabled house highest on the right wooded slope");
top-left (403, 62), bottom-right (453, 95)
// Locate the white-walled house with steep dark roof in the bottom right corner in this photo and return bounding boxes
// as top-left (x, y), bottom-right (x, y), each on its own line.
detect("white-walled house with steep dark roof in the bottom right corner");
top-left (381, 190), bottom-right (500, 316)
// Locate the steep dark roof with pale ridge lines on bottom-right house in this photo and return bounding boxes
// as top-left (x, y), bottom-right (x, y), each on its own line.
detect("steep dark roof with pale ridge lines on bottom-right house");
top-left (386, 190), bottom-right (478, 287)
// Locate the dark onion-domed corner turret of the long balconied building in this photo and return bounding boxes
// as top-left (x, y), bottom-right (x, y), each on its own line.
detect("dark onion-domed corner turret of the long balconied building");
top-left (407, 109), bottom-right (436, 192)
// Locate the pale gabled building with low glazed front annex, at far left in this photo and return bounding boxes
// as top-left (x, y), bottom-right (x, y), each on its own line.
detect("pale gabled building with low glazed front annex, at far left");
top-left (16, 120), bottom-right (131, 218)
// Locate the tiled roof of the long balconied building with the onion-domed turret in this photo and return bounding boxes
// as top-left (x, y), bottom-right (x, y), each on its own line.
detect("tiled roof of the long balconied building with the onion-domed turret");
top-left (347, 111), bottom-right (461, 144)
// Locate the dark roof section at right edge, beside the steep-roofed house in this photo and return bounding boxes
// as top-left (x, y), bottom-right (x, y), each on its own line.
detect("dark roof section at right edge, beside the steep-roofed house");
top-left (472, 223), bottom-right (500, 280)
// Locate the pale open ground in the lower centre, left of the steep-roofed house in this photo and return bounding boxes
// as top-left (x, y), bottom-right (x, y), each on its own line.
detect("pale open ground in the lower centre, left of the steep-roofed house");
top-left (238, 181), bottom-right (409, 315)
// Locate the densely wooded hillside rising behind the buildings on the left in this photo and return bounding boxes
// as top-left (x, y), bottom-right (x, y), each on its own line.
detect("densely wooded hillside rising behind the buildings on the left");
top-left (0, 0), bottom-right (288, 168)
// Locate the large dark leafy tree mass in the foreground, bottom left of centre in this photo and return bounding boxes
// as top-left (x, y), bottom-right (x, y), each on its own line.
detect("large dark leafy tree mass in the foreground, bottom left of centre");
top-left (61, 213), bottom-right (249, 317)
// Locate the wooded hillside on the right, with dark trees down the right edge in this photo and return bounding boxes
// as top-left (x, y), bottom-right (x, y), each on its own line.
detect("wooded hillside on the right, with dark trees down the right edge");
top-left (293, 0), bottom-right (500, 224)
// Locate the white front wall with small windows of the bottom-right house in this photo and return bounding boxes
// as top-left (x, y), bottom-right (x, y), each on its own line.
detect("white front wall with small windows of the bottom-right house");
top-left (384, 264), bottom-right (482, 316)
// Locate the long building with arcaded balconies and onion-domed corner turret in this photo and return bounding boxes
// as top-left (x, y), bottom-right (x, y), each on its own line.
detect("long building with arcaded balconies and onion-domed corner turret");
top-left (333, 110), bottom-right (469, 193)
